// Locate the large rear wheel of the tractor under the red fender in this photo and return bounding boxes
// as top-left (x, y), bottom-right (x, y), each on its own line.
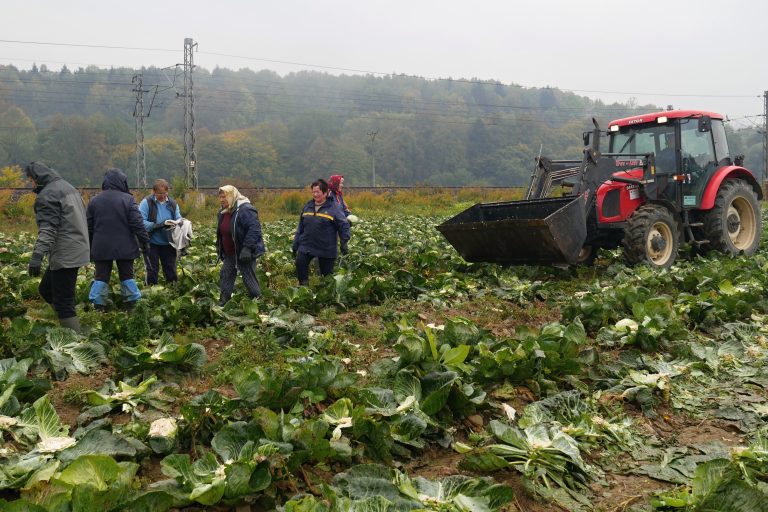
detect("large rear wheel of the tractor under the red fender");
top-left (704, 180), bottom-right (763, 256)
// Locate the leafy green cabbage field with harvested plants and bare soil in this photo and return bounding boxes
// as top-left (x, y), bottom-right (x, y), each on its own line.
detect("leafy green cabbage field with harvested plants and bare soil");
top-left (0, 216), bottom-right (768, 512)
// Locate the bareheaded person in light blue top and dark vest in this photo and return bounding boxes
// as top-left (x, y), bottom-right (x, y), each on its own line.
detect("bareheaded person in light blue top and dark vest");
top-left (139, 179), bottom-right (181, 284)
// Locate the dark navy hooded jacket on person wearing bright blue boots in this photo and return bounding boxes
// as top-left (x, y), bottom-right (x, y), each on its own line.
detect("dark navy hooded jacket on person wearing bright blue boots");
top-left (87, 169), bottom-right (149, 261)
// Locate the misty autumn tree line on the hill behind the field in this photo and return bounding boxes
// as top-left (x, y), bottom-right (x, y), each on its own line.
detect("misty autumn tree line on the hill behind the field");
top-left (0, 66), bottom-right (762, 186)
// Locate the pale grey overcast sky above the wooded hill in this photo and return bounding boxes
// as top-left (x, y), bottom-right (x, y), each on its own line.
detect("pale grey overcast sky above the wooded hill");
top-left (0, 0), bottom-right (768, 128)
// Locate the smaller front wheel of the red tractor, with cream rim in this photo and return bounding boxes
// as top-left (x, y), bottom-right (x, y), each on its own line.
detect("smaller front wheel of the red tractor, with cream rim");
top-left (622, 204), bottom-right (680, 268)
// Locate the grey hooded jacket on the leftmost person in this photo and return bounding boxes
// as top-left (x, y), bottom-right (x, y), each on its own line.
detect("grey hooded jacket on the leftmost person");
top-left (26, 162), bottom-right (88, 270)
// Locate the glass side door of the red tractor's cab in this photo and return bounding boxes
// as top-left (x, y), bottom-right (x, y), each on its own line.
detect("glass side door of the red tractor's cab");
top-left (680, 118), bottom-right (730, 208)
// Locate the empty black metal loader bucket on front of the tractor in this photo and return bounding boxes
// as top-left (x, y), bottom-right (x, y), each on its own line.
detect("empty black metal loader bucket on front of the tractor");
top-left (437, 196), bottom-right (587, 264)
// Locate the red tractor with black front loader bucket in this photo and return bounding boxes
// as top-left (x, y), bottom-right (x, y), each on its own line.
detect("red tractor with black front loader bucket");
top-left (438, 110), bottom-right (762, 268)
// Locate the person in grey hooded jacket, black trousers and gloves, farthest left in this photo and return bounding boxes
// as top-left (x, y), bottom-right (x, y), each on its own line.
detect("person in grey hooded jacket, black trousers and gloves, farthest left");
top-left (24, 162), bottom-right (89, 332)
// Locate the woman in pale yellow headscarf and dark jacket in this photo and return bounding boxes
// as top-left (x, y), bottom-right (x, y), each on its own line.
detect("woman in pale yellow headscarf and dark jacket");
top-left (216, 185), bottom-right (267, 306)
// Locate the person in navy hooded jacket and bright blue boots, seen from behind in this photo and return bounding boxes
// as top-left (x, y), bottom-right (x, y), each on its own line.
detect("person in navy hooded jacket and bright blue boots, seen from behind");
top-left (87, 169), bottom-right (149, 311)
